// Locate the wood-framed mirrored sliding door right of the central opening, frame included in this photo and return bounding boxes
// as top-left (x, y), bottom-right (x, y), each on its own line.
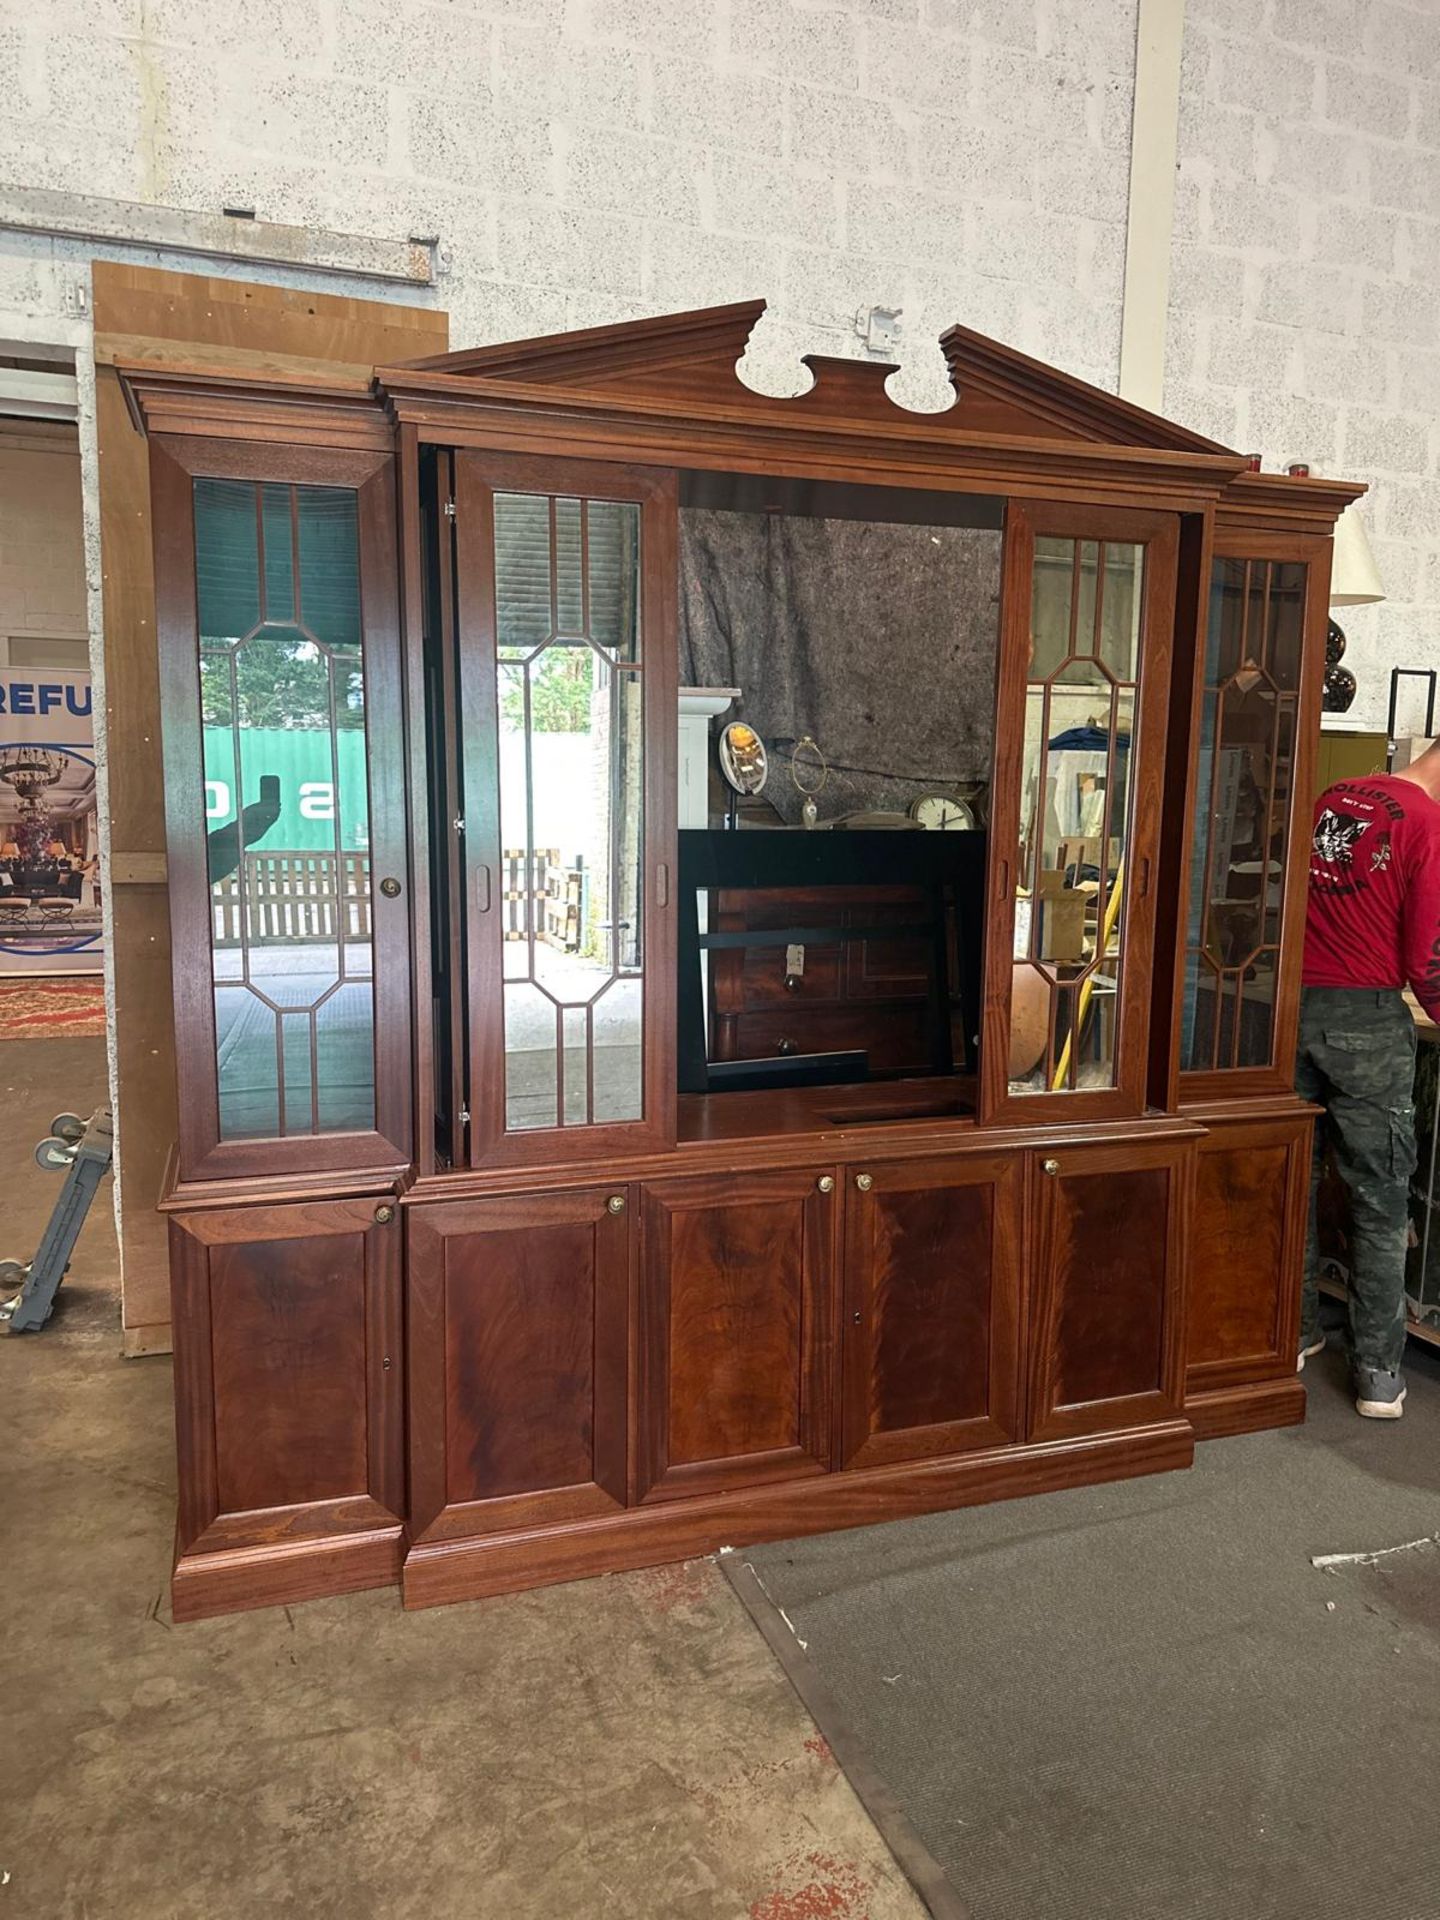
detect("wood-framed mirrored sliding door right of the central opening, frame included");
top-left (987, 505), bottom-right (1175, 1117)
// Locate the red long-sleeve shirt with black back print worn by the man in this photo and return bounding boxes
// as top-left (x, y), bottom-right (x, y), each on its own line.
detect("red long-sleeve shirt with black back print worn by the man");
top-left (1302, 774), bottom-right (1440, 1021)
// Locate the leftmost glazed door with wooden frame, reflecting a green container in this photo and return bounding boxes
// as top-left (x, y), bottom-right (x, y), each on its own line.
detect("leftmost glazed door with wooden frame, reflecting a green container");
top-left (150, 436), bottom-right (411, 1179)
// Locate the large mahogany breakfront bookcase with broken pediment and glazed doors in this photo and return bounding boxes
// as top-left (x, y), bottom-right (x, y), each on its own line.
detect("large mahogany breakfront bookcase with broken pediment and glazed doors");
top-left (121, 303), bottom-right (1361, 1619)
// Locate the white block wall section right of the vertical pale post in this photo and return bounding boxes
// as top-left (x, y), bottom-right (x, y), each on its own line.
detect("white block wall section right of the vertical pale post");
top-left (1165, 0), bottom-right (1440, 728)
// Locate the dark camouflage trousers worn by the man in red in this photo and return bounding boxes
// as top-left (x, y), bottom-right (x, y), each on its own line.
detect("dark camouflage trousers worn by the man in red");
top-left (1296, 987), bottom-right (1415, 1373)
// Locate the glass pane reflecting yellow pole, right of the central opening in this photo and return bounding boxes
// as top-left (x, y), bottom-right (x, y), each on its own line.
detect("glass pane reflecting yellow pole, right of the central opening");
top-left (1008, 536), bottom-right (1146, 1094)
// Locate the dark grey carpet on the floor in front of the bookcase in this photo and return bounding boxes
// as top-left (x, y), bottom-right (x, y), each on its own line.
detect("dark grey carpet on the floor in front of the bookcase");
top-left (735, 1342), bottom-right (1440, 1920)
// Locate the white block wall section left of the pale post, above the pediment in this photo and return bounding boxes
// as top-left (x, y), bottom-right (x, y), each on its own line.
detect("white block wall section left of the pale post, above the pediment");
top-left (0, 0), bottom-right (1135, 405)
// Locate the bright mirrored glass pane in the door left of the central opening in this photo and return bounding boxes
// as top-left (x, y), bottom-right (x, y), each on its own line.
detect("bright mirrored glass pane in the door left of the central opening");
top-left (493, 492), bottom-right (645, 1133)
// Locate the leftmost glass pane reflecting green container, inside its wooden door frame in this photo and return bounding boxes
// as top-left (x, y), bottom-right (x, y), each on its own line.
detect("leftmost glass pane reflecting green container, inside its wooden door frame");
top-left (194, 478), bottom-right (376, 1140)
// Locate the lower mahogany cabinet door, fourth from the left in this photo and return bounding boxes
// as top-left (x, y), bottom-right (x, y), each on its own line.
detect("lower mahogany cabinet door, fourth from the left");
top-left (841, 1154), bottom-right (1025, 1467)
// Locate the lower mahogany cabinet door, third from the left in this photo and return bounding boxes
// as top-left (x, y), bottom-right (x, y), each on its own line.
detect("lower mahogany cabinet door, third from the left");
top-left (636, 1167), bottom-right (839, 1500)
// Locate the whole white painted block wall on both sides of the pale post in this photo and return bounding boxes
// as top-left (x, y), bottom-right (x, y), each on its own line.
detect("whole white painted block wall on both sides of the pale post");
top-left (0, 0), bottom-right (1440, 720)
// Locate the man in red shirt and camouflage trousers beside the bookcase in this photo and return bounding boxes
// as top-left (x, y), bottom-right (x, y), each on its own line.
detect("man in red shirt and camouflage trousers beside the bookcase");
top-left (1296, 745), bottom-right (1440, 1421)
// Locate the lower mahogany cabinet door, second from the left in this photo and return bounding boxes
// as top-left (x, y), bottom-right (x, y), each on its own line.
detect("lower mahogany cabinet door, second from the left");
top-left (407, 1188), bottom-right (630, 1542)
